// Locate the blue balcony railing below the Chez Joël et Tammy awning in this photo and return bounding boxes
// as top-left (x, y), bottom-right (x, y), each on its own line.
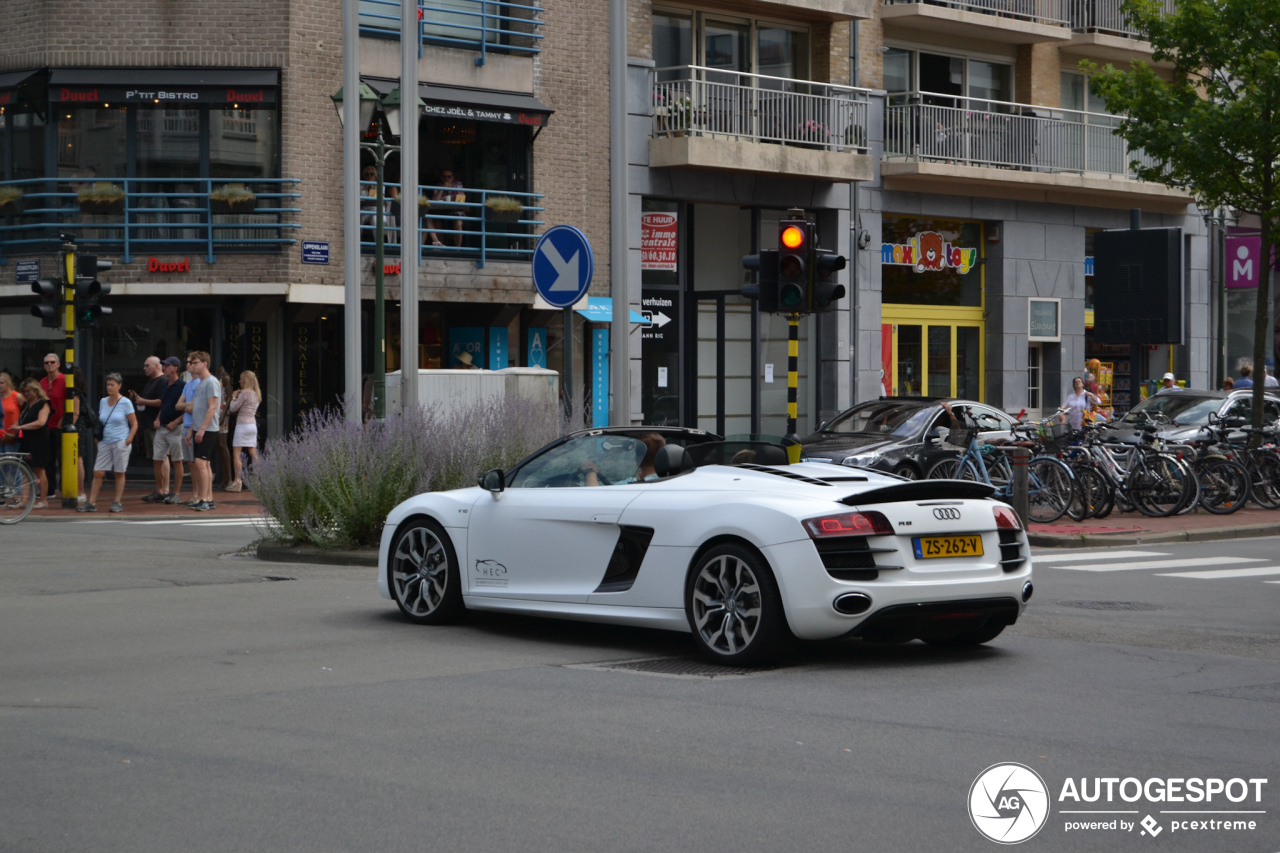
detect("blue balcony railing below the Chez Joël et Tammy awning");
top-left (360, 182), bottom-right (543, 269)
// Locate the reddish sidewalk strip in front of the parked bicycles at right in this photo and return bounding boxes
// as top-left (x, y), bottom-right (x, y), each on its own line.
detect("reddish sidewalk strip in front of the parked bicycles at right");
top-left (1027, 506), bottom-right (1280, 548)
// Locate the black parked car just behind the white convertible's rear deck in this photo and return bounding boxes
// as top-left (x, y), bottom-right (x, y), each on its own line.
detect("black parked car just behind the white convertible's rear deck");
top-left (800, 397), bottom-right (1016, 479)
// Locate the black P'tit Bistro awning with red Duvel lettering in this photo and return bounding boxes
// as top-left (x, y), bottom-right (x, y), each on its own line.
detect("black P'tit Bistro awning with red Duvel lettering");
top-left (49, 68), bottom-right (280, 106)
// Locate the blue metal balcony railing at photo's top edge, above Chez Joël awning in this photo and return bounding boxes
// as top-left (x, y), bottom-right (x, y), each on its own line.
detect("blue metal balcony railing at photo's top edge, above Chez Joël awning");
top-left (360, 0), bottom-right (543, 65)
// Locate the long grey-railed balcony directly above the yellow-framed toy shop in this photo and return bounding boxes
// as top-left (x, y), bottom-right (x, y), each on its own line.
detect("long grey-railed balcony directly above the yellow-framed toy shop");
top-left (881, 92), bottom-right (1190, 210)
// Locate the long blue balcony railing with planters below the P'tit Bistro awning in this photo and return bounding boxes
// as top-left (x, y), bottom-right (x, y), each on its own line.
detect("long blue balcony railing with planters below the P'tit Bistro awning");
top-left (0, 178), bottom-right (302, 264)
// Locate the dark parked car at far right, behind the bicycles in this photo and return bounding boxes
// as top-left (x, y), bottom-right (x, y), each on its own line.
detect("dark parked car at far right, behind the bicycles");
top-left (1103, 388), bottom-right (1280, 444)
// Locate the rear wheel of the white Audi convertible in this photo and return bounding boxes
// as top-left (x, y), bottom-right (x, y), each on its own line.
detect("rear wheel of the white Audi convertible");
top-left (685, 543), bottom-right (790, 666)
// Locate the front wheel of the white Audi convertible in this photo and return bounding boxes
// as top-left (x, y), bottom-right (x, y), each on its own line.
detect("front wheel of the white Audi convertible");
top-left (387, 519), bottom-right (463, 625)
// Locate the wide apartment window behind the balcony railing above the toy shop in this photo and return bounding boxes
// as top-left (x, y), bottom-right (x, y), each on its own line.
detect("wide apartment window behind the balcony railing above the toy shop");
top-left (884, 47), bottom-right (1014, 109)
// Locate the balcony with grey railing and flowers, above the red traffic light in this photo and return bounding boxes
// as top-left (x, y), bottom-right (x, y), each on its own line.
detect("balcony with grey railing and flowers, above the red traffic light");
top-left (649, 65), bottom-right (872, 182)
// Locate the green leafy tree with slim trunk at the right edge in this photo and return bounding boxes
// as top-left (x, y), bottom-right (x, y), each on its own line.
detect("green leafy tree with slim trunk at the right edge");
top-left (1082, 0), bottom-right (1280, 425)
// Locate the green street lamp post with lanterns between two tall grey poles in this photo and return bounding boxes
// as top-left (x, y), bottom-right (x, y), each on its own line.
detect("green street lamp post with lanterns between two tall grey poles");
top-left (332, 83), bottom-right (421, 420)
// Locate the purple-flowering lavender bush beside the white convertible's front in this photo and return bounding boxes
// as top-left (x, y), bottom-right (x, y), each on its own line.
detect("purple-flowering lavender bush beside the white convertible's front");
top-left (252, 397), bottom-right (581, 548)
